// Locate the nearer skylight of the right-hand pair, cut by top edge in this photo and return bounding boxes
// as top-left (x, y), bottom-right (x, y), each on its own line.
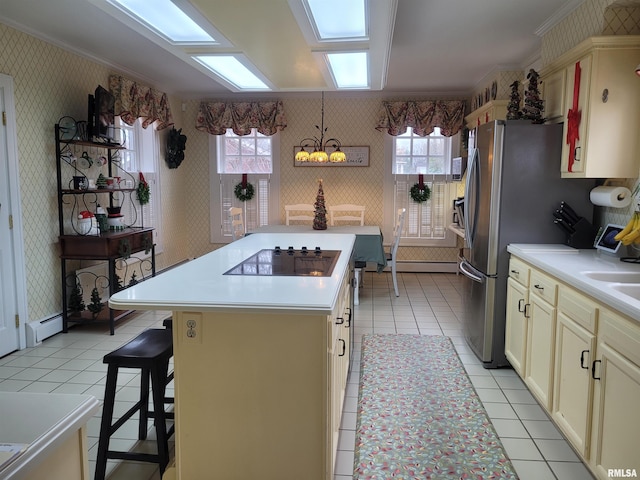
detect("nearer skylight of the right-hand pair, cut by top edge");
top-left (305, 0), bottom-right (368, 40)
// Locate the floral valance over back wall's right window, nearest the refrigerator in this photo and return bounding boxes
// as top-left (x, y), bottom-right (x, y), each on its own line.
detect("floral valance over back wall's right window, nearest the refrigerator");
top-left (376, 100), bottom-right (464, 137)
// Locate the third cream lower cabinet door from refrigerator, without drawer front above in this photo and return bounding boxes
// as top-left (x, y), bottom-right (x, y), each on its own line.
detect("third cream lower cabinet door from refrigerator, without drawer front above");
top-left (552, 307), bottom-right (596, 458)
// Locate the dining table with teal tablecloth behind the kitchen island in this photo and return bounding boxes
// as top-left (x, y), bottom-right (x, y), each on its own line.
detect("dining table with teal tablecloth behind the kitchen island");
top-left (248, 225), bottom-right (387, 305)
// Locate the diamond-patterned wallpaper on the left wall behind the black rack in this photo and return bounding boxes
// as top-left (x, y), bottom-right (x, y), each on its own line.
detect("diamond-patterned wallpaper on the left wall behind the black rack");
top-left (0, 24), bottom-right (186, 320)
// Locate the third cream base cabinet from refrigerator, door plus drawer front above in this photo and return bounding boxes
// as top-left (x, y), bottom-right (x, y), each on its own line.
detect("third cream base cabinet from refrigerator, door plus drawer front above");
top-left (551, 285), bottom-right (598, 458)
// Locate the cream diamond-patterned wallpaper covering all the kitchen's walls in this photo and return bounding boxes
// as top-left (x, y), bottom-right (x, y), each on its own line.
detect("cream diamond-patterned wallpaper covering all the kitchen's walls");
top-left (5, 0), bottom-right (640, 326)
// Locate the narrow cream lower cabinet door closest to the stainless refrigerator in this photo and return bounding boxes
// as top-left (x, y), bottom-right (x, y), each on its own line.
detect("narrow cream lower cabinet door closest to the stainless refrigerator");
top-left (504, 278), bottom-right (529, 377)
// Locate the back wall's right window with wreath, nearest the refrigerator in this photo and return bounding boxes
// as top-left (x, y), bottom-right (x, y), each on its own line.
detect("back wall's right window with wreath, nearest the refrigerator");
top-left (384, 128), bottom-right (459, 247)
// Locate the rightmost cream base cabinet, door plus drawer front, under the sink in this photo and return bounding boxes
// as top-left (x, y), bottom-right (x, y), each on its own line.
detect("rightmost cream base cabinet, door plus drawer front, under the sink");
top-left (589, 308), bottom-right (640, 480)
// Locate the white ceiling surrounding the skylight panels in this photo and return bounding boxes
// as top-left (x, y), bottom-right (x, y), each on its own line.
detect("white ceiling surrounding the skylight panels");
top-left (0, 0), bottom-right (584, 98)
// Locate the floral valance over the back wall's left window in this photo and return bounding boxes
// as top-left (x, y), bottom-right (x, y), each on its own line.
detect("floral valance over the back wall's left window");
top-left (196, 100), bottom-right (287, 135)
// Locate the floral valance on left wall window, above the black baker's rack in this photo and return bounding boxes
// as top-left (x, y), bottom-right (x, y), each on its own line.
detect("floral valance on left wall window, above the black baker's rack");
top-left (109, 75), bottom-right (173, 130)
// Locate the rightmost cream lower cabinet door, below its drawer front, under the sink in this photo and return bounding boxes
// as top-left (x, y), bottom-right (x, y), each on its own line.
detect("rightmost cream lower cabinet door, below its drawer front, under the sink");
top-left (590, 343), bottom-right (640, 480)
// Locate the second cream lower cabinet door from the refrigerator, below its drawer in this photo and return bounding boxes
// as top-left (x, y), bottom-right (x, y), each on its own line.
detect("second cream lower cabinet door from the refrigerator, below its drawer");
top-left (525, 290), bottom-right (556, 411)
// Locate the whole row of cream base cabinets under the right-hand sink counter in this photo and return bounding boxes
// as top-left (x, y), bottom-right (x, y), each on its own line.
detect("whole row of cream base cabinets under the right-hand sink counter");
top-left (505, 253), bottom-right (640, 480)
